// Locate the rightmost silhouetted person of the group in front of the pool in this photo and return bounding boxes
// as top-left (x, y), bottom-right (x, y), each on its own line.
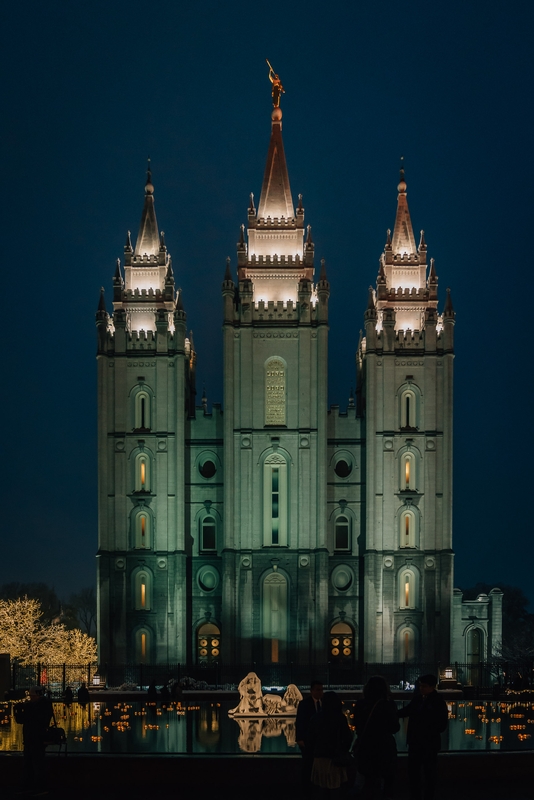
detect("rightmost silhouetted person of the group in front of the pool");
top-left (398, 675), bottom-right (449, 800)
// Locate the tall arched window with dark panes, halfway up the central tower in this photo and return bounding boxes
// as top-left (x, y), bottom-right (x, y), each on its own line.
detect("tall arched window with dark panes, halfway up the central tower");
top-left (263, 452), bottom-right (288, 546)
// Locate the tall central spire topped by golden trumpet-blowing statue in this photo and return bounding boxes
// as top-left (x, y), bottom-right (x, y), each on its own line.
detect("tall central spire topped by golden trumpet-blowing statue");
top-left (258, 61), bottom-right (295, 219)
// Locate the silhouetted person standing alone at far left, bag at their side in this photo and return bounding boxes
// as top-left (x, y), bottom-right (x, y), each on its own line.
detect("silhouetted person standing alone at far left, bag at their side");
top-left (13, 686), bottom-right (54, 795)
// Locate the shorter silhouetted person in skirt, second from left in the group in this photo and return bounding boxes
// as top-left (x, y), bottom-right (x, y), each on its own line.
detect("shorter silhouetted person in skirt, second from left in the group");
top-left (308, 692), bottom-right (353, 798)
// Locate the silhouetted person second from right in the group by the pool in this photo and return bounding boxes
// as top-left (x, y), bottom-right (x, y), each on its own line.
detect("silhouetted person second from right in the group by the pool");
top-left (354, 675), bottom-right (400, 799)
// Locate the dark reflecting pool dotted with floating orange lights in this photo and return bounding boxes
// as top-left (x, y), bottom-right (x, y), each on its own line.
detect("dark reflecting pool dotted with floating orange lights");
top-left (0, 697), bottom-right (534, 755)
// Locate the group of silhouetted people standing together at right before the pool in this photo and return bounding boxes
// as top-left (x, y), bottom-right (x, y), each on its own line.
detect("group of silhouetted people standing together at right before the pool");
top-left (296, 675), bottom-right (448, 800)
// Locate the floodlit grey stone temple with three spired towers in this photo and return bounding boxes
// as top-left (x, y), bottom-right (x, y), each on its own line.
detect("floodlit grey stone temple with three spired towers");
top-left (96, 97), bottom-right (502, 667)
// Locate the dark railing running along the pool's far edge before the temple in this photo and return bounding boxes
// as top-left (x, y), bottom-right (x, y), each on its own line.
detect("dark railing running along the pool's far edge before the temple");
top-left (11, 660), bottom-right (534, 697)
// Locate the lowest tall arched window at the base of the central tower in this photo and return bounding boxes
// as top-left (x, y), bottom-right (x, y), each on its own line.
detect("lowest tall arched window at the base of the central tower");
top-left (262, 572), bottom-right (288, 664)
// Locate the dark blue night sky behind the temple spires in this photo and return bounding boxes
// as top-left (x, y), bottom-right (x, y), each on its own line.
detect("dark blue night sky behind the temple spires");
top-left (0, 0), bottom-right (534, 601)
